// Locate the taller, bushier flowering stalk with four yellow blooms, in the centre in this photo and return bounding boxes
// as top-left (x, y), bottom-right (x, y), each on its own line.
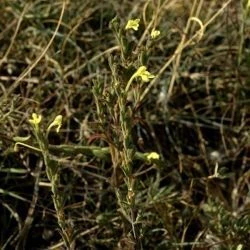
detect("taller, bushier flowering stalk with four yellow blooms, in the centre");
top-left (92, 18), bottom-right (159, 246)
